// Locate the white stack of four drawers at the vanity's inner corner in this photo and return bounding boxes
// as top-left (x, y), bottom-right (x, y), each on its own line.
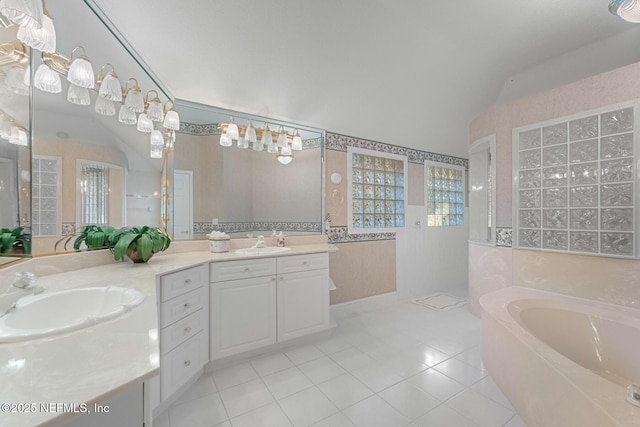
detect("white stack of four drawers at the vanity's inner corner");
top-left (158, 264), bottom-right (209, 400)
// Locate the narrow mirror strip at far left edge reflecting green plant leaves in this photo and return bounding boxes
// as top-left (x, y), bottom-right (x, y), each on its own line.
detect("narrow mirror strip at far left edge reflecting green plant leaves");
top-left (0, 25), bottom-right (31, 265)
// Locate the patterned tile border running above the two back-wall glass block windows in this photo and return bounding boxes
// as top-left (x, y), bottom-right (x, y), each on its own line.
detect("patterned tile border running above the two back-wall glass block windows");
top-left (325, 132), bottom-right (469, 170)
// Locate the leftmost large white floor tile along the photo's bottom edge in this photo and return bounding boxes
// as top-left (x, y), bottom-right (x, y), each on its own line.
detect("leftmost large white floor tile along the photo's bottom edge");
top-left (169, 393), bottom-right (228, 427)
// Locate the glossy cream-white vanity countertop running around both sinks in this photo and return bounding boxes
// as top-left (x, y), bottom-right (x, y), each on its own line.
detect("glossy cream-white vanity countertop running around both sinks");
top-left (0, 243), bottom-right (335, 426)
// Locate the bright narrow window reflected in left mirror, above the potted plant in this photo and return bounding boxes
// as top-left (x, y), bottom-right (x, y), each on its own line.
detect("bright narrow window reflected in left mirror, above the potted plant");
top-left (80, 162), bottom-right (109, 224)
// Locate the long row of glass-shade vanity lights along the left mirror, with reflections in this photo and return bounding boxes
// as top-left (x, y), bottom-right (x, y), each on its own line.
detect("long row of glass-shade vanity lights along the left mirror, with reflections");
top-left (0, 0), bottom-right (180, 158)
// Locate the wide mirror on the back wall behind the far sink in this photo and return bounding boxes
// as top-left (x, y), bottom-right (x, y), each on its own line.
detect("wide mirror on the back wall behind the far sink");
top-left (173, 101), bottom-right (324, 239)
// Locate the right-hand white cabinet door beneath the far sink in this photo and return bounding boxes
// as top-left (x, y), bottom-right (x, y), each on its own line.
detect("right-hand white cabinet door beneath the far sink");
top-left (278, 269), bottom-right (329, 342)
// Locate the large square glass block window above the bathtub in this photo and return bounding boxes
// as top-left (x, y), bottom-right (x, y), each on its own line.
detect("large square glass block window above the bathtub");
top-left (514, 105), bottom-right (638, 257)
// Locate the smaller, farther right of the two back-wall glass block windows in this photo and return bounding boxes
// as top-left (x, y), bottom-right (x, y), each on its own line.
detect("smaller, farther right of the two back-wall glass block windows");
top-left (425, 162), bottom-right (464, 227)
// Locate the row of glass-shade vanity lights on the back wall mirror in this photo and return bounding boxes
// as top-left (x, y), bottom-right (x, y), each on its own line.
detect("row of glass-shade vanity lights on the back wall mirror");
top-left (218, 117), bottom-right (302, 165)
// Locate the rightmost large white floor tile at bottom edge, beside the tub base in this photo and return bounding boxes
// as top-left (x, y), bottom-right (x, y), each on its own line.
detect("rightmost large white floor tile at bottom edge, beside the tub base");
top-left (446, 388), bottom-right (514, 427)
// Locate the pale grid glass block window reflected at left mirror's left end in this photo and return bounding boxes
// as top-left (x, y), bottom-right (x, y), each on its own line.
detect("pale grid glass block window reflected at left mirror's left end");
top-left (31, 156), bottom-right (60, 236)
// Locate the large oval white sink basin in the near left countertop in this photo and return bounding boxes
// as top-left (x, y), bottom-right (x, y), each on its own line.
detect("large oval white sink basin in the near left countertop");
top-left (0, 286), bottom-right (145, 343)
